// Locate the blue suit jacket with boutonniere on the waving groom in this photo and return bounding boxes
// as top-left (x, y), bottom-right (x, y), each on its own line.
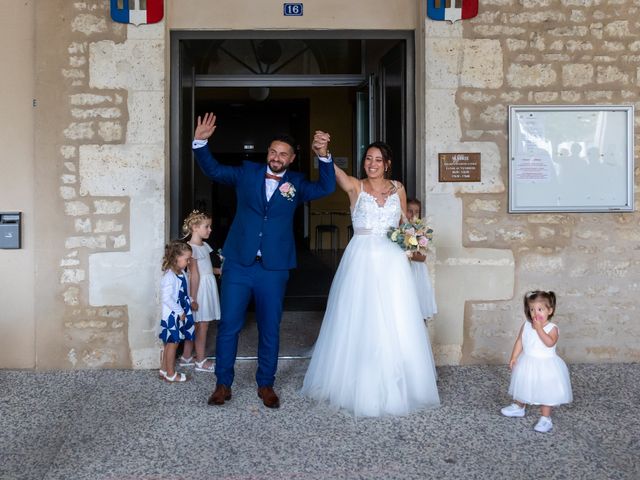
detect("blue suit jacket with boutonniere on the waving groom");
top-left (194, 145), bottom-right (336, 270)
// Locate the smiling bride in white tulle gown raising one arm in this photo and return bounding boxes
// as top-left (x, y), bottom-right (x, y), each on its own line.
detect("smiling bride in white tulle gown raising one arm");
top-left (302, 142), bottom-right (440, 416)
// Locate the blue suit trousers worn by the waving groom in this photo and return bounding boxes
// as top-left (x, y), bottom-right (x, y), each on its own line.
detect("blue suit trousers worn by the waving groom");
top-left (216, 258), bottom-right (289, 387)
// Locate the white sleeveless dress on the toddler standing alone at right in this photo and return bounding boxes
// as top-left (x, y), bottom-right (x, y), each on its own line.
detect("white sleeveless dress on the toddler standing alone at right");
top-left (509, 322), bottom-right (573, 406)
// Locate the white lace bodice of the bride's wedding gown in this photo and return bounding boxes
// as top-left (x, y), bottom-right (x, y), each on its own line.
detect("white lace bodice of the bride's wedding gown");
top-left (351, 190), bottom-right (402, 235)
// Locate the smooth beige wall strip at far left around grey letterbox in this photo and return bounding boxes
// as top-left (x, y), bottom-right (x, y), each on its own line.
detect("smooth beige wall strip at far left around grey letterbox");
top-left (0, 0), bottom-right (36, 368)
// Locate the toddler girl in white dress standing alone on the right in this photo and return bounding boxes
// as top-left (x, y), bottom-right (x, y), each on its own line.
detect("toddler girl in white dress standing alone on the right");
top-left (501, 290), bottom-right (573, 433)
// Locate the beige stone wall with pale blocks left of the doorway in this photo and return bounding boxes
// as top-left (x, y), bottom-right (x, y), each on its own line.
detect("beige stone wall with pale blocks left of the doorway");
top-left (36, 0), bottom-right (165, 368)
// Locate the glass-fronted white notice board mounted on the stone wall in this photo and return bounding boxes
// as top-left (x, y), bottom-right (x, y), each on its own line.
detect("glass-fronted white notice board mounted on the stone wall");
top-left (509, 105), bottom-right (634, 213)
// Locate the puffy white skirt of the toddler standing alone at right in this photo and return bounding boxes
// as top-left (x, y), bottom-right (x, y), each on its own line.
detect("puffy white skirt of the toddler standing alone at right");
top-left (509, 353), bottom-right (573, 406)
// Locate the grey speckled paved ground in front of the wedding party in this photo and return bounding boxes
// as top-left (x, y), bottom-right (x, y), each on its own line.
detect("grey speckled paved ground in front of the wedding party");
top-left (0, 360), bottom-right (640, 480)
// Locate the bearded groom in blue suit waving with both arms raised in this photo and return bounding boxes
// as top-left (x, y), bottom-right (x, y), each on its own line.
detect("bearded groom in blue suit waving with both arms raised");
top-left (193, 113), bottom-right (336, 408)
